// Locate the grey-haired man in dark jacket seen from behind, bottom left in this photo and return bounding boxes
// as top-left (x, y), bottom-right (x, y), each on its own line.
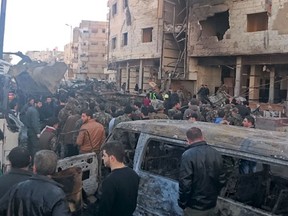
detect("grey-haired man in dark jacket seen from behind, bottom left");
top-left (1, 150), bottom-right (70, 216)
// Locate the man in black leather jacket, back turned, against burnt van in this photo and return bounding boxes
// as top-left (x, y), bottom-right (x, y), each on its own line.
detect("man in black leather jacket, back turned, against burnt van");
top-left (178, 127), bottom-right (226, 216)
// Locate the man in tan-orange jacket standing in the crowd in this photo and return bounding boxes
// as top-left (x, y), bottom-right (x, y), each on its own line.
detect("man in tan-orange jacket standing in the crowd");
top-left (76, 110), bottom-right (105, 154)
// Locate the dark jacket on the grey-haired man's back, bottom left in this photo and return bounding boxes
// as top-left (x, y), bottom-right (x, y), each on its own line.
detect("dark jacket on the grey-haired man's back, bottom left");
top-left (7, 175), bottom-right (70, 216)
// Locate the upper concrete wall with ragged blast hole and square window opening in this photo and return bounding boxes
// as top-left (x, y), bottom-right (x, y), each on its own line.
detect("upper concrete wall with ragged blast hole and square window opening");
top-left (188, 0), bottom-right (288, 56)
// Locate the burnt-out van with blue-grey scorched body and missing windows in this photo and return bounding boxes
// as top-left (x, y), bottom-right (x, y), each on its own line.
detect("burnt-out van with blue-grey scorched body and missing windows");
top-left (108, 120), bottom-right (288, 216)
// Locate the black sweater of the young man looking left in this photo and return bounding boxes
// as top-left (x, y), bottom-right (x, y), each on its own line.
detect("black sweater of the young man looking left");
top-left (99, 167), bottom-right (139, 216)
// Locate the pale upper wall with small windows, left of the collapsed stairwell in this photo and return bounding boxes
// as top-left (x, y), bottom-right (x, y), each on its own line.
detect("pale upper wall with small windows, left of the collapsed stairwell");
top-left (108, 0), bottom-right (163, 63)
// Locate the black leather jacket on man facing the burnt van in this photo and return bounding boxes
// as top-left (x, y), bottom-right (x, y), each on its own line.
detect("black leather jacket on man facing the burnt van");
top-left (180, 142), bottom-right (225, 210)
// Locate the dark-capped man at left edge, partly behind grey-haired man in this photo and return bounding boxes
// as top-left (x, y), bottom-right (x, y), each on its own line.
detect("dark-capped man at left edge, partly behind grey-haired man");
top-left (0, 147), bottom-right (33, 197)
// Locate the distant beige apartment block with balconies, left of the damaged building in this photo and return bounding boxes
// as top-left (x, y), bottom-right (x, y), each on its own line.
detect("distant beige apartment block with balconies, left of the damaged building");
top-left (64, 20), bottom-right (108, 79)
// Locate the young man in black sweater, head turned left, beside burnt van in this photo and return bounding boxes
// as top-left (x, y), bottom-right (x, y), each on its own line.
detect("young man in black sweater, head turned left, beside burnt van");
top-left (99, 141), bottom-right (139, 216)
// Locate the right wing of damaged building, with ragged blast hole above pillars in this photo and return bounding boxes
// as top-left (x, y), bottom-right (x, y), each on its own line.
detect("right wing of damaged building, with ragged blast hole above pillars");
top-left (187, 0), bottom-right (288, 103)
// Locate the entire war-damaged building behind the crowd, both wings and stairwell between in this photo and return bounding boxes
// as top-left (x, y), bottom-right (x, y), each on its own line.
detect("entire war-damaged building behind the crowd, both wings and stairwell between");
top-left (108, 0), bottom-right (288, 103)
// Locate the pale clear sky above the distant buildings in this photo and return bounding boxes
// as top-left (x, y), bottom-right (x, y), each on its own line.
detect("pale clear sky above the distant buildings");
top-left (4, 0), bottom-right (108, 53)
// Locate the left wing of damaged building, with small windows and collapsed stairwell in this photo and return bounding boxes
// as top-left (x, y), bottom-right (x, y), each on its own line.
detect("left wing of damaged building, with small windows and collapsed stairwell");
top-left (108, 0), bottom-right (189, 91)
